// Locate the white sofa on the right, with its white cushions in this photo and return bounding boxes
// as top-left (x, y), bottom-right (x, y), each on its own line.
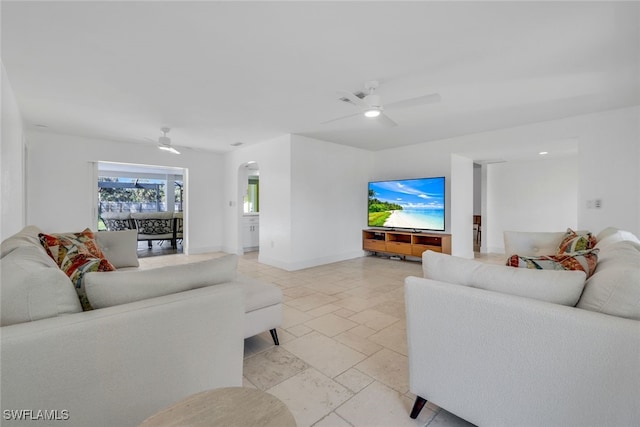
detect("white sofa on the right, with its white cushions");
top-left (405, 229), bottom-right (640, 427)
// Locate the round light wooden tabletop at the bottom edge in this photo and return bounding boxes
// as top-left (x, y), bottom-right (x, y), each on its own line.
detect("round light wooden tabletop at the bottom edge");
top-left (140, 387), bottom-right (296, 427)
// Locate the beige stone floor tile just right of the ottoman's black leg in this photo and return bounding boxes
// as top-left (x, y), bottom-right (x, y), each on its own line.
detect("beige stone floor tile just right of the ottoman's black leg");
top-left (283, 332), bottom-right (367, 378)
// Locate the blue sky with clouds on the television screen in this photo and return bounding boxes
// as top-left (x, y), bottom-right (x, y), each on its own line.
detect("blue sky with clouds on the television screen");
top-left (369, 178), bottom-right (444, 209)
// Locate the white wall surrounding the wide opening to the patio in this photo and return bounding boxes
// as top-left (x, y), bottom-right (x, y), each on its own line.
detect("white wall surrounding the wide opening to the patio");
top-left (26, 132), bottom-right (224, 253)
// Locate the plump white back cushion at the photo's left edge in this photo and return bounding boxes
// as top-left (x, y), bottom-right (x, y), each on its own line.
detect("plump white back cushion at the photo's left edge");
top-left (0, 246), bottom-right (82, 326)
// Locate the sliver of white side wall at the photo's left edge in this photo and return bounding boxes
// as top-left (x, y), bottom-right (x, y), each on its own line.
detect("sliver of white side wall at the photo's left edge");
top-left (0, 65), bottom-right (26, 240)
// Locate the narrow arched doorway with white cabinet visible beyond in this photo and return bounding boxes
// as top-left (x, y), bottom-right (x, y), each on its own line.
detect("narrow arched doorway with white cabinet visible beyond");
top-left (238, 161), bottom-right (260, 253)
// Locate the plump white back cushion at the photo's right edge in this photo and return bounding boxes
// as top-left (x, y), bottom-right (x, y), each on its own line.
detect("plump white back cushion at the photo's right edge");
top-left (577, 241), bottom-right (640, 320)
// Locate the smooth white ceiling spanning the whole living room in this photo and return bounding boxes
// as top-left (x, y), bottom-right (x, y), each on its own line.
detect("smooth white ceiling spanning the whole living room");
top-left (1, 1), bottom-right (640, 152)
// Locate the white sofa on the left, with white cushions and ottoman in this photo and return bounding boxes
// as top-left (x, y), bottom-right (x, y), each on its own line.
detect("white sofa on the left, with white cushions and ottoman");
top-left (0, 227), bottom-right (282, 426)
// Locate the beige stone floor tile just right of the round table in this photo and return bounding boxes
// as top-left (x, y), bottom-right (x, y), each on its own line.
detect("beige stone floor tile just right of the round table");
top-left (267, 368), bottom-right (353, 427)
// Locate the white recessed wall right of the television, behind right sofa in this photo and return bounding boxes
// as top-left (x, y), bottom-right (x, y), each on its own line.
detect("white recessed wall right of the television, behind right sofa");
top-left (482, 156), bottom-right (578, 253)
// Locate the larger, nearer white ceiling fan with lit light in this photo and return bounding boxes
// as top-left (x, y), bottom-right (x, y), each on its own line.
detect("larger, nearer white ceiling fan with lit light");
top-left (322, 80), bottom-right (441, 127)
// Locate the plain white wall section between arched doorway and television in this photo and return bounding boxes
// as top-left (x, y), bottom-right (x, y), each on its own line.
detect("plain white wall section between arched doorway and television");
top-left (287, 135), bottom-right (372, 270)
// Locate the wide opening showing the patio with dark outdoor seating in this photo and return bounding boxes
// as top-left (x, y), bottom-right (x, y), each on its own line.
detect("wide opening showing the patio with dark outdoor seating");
top-left (95, 162), bottom-right (187, 258)
